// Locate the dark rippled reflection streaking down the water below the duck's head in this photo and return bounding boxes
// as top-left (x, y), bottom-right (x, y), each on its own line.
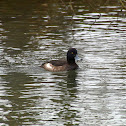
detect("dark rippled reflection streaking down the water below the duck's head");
top-left (55, 71), bottom-right (80, 125)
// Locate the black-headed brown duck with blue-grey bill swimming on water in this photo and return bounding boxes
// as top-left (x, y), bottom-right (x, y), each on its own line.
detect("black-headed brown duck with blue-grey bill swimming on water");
top-left (41, 48), bottom-right (79, 72)
